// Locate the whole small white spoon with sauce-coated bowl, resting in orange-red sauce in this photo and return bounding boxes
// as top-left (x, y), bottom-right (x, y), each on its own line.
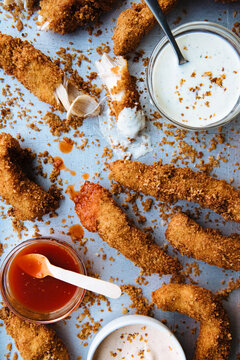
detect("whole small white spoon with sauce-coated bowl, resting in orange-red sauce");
top-left (18, 254), bottom-right (121, 299)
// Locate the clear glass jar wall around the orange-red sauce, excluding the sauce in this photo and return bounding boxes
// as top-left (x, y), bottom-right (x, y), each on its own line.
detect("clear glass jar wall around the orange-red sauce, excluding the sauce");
top-left (0, 237), bottom-right (86, 324)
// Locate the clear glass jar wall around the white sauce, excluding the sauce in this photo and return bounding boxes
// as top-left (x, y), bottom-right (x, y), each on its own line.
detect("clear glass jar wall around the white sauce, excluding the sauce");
top-left (147, 21), bottom-right (240, 131)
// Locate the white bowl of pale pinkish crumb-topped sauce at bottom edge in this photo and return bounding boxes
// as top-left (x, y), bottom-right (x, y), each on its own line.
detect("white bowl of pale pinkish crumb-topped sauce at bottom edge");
top-left (87, 315), bottom-right (186, 360)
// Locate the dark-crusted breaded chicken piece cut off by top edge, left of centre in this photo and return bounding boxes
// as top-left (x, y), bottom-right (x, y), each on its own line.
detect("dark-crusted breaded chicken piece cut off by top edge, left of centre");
top-left (39, 0), bottom-right (115, 34)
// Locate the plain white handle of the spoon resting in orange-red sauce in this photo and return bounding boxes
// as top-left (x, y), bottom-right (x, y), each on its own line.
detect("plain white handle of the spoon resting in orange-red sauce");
top-left (48, 264), bottom-right (121, 299)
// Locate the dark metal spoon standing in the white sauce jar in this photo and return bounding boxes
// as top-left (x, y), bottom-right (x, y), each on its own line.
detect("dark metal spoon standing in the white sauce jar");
top-left (145, 0), bottom-right (188, 65)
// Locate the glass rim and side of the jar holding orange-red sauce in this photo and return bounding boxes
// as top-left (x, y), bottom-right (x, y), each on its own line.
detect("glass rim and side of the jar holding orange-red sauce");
top-left (0, 236), bottom-right (87, 324)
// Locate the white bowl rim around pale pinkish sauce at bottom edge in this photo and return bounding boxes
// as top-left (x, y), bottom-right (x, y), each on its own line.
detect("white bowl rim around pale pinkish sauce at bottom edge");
top-left (87, 315), bottom-right (186, 360)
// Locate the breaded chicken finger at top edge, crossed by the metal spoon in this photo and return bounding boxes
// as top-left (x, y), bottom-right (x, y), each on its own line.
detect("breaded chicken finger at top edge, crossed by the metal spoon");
top-left (112, 0), bottom-right (177, 55)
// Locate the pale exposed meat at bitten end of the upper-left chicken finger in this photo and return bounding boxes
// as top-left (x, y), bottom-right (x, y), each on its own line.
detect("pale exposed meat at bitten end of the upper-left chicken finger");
top-left (54, 78), bottom-right (100, 120)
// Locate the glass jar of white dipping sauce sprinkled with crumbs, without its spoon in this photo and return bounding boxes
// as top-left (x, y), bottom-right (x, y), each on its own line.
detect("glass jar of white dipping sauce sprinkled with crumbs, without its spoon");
top-left (147, 22), bottom-right (240, 130)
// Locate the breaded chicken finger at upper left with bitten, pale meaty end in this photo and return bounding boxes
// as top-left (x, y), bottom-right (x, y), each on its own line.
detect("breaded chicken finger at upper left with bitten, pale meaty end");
top-left (0, 33), bottom-right (99, 117)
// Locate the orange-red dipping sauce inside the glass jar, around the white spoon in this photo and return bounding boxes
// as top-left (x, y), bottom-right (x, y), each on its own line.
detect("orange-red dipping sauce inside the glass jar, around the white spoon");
top-left (8, 239), bottom-right (84, 313)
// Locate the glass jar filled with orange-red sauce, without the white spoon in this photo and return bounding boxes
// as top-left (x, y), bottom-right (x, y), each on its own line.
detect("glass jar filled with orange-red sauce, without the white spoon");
top-left (1, 237), bottom-right (86, 323)
